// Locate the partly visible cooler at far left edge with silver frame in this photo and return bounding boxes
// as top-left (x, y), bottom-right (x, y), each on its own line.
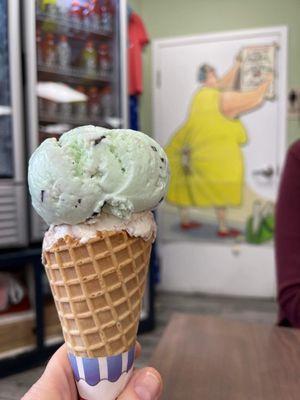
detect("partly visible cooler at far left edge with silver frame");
top-left (0, 0), bottom-right (27, 248)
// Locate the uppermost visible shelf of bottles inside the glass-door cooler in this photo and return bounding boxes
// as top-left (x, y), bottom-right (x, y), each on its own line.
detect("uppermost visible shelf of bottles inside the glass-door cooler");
top-left (36, 13), bottom-right (113, 39)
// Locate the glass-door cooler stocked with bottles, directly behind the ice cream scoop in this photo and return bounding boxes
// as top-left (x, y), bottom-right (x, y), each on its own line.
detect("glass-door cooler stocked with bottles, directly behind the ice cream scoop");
top-left (24, 0), bottom-right (127, 241)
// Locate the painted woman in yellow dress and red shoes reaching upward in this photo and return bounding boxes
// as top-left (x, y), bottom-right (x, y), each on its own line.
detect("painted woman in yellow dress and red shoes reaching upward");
top-left (166, 59), bottom-right (272, 237)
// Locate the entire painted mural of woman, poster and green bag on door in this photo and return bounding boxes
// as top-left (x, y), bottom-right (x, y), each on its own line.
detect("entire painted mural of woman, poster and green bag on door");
top-left (166, 44), bottom-right (277, 244)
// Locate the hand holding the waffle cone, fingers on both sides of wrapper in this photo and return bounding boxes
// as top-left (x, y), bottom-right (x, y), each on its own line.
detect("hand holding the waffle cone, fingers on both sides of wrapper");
top-left (21, 343), bottom-right (162, 400)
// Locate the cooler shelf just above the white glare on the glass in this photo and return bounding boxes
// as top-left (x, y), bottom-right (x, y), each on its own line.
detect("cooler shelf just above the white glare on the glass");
top-left (37, 64), bottom-right (112, 84)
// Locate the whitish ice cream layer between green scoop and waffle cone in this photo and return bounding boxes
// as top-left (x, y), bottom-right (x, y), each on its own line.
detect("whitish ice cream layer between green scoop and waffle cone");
top-left (43, 211), bottom-right (156, 251)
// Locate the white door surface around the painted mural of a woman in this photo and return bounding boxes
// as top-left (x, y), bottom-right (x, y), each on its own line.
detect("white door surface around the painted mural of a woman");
top-left (153, 27), bottom-right (287, 296)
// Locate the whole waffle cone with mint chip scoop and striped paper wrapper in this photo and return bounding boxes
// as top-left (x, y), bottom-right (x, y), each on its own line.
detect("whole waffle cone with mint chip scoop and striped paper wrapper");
top-left (28, 125), bottom-right (169, 400)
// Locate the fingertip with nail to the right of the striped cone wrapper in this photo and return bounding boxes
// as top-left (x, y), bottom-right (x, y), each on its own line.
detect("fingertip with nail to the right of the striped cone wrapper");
top-left (118, 367), bottom-right (162, 400)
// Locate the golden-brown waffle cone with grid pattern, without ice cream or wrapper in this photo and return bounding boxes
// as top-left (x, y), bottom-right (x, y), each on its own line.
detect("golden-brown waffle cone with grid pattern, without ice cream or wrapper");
top-left (43, 231), bottom-right (152, 357)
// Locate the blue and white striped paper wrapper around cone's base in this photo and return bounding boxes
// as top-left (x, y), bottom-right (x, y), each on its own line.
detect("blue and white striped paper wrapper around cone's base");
top-left (68, 346), bottom-right (135, 400)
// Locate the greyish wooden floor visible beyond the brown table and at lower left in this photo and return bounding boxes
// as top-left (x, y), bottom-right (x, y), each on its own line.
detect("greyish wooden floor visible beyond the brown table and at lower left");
top-left (0, 293), bottom-right (276, 400)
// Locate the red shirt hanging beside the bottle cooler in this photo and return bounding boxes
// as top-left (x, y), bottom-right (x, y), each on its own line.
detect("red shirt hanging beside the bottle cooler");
top-left (128, 12), bottom-right (149, 95)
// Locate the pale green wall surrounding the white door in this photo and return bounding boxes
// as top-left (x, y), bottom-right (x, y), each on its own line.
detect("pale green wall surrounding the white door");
top-left (134, 0), bottom-right (300, 142)
